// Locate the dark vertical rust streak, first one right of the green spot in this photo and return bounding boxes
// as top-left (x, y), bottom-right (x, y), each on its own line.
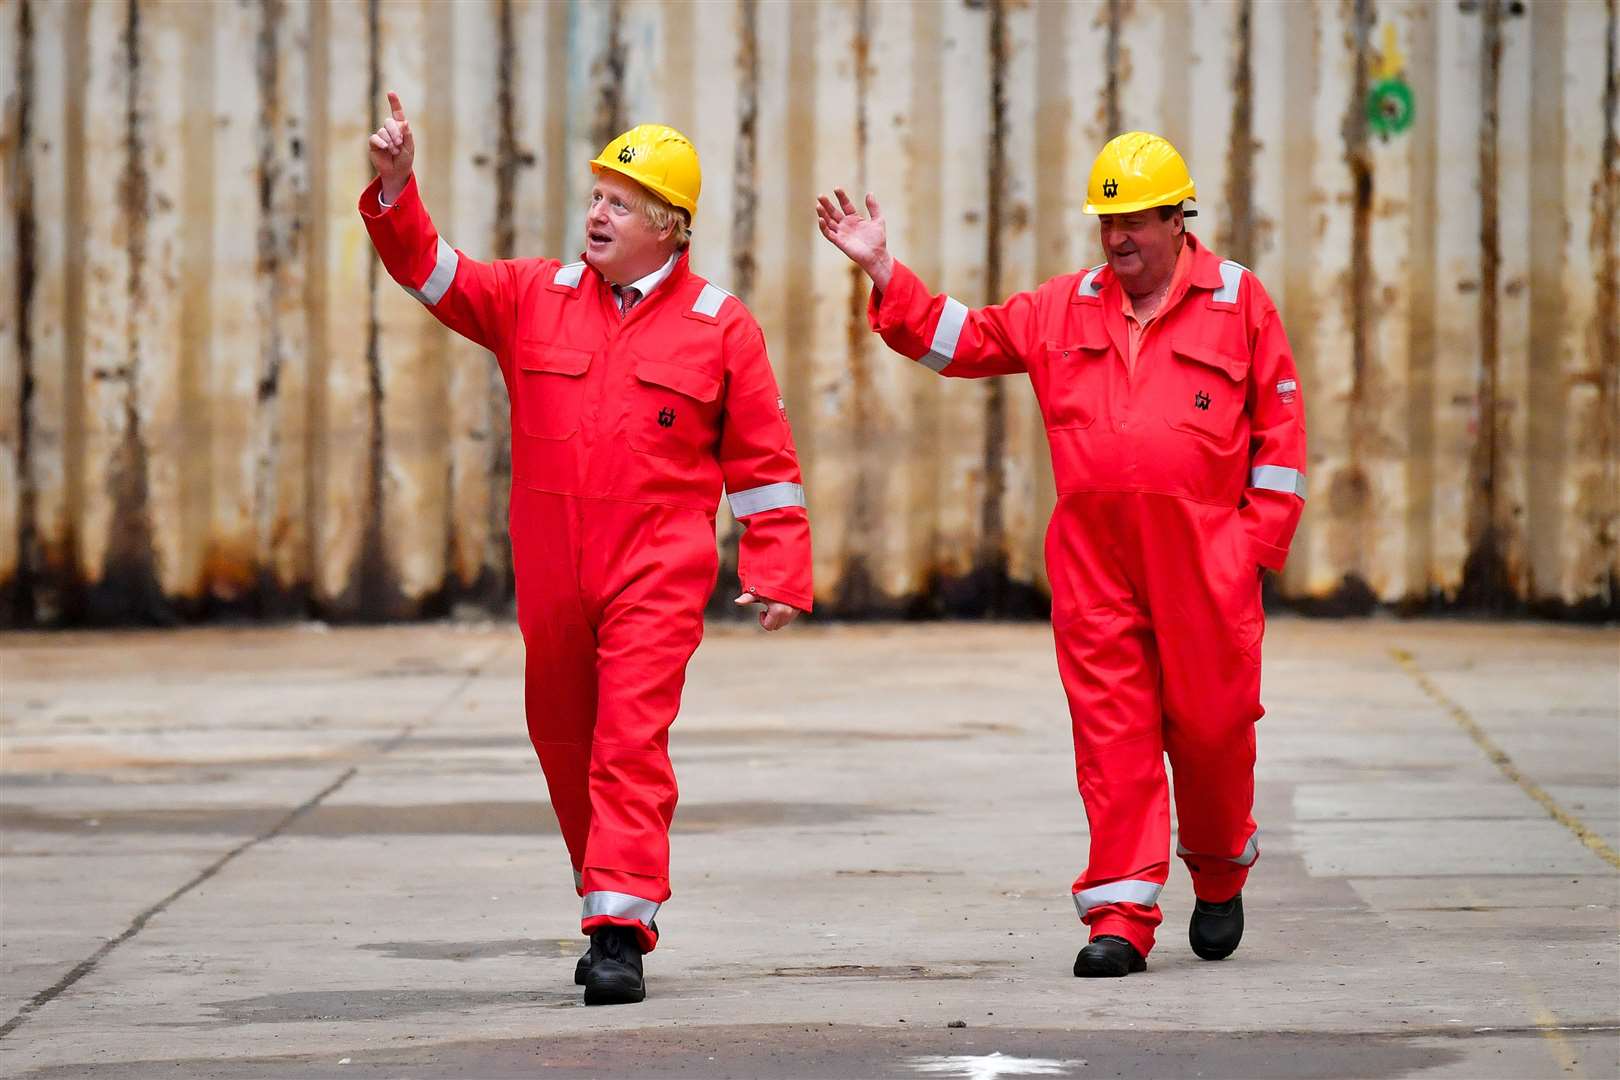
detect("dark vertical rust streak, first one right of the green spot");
top-left (1458, 0), bottom-right (1515, 610)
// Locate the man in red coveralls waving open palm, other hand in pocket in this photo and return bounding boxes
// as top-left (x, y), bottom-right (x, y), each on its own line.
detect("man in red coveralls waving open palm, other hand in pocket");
top-left (816, 131), bottom-right (1306, 976)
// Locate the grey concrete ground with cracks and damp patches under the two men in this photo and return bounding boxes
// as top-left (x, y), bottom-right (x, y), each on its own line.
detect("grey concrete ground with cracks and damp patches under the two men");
top-left (0, 619), bottom-right (1620, 1078)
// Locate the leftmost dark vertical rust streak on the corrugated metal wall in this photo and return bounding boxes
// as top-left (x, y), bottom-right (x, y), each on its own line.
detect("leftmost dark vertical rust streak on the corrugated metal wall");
top-left (10, 0), bottom-right (39, 625)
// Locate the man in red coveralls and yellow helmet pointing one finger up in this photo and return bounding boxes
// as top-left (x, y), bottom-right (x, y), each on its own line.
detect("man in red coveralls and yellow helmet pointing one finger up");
top-left (360, 94), bottom-right (812, 1004)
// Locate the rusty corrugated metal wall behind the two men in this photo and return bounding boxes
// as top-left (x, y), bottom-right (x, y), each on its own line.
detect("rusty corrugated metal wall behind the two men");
top-left (0, 0), bottom-right (1620, 625)
